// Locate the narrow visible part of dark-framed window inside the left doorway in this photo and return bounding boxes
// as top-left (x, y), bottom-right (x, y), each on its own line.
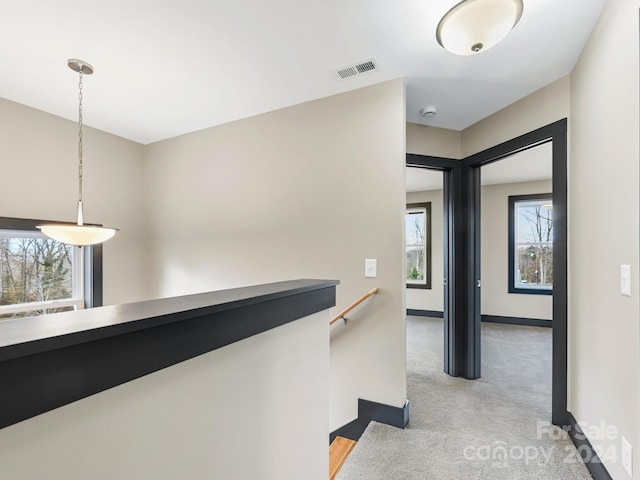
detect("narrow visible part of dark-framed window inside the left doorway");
top-left (405, 202), bottom-right (431, 288)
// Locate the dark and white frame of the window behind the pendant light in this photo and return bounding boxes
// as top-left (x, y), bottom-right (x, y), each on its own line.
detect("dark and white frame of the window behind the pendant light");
top-left (0, 217), bottom-right (102, 313)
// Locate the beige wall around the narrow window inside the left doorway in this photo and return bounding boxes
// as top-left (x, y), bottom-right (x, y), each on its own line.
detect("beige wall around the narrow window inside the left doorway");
top-left (407, 186), bottom-right (444, 312)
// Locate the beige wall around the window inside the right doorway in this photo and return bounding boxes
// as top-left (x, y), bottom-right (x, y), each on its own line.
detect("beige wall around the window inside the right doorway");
top-left (480, 181), bottom-right (553, 320)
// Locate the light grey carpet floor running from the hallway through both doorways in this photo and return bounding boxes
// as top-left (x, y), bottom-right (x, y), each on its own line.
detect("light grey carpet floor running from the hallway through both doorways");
top-left (337, 317), bottom-right (591, 480)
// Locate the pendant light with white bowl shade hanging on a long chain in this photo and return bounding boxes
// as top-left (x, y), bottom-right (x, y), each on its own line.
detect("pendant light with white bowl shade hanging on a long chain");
top-left (37, 58), bottom-right (118, 246)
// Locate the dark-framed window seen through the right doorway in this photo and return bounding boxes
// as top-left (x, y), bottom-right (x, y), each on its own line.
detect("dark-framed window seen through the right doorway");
top-left (509, 193), bottom-right (553, 295)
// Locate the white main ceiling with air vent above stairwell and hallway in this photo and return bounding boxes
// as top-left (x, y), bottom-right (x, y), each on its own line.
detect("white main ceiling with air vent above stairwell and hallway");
top-left (0, 0), bottom-right (606, 144)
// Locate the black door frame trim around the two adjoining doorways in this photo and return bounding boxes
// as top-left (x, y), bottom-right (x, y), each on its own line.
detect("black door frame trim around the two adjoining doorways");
top-left (406, 118), bottom-right (569, 425)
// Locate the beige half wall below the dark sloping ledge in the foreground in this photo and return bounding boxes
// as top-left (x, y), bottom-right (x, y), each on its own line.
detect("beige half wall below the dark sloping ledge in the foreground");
top-left (0, 310), bottom-right (329, 480)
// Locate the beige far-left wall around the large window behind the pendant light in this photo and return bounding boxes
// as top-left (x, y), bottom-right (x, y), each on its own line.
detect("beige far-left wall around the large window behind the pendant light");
top-left (0, 99), bottom-right (147, 304)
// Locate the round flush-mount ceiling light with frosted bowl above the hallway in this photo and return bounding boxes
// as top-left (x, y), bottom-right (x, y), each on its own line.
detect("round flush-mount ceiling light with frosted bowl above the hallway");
top-left (436, 0), bottom-right (524, 55)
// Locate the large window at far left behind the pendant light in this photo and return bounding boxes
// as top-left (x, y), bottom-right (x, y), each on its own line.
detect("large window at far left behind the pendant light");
top-left (0, 217), bottom-right (102, 320)
